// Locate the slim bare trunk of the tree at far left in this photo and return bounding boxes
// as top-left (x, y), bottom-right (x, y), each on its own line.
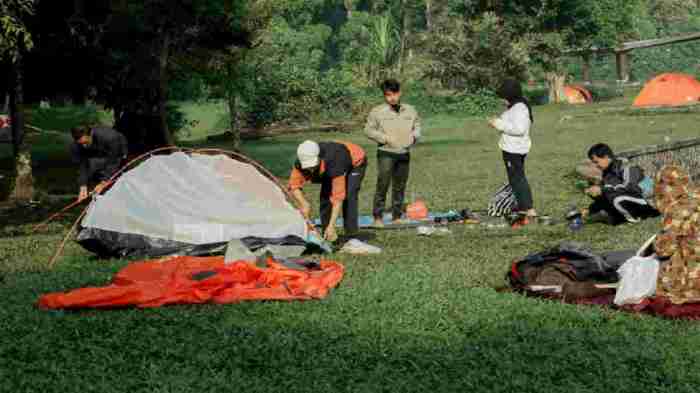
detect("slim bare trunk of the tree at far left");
top-left (10, 51), bottom-right (34, 201)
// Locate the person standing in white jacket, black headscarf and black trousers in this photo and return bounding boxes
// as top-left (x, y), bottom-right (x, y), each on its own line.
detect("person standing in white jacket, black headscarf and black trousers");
top-left (489, 79), bottom-right (537, 225)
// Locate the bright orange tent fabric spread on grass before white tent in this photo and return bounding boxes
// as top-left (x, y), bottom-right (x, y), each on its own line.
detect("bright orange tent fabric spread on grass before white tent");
top-left (38, 257), bottom-right (344, 309)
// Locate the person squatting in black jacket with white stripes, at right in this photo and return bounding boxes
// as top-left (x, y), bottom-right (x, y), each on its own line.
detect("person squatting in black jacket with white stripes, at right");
top-left (584, 143), bottom-right (659, 225)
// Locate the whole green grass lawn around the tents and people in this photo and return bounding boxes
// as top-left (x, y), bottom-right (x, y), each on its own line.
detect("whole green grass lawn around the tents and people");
top-left (0, 95), bottom-right (700, 393)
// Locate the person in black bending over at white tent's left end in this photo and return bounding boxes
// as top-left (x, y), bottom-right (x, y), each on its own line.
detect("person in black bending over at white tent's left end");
top-left (71, 126), bottom-right (128, 200)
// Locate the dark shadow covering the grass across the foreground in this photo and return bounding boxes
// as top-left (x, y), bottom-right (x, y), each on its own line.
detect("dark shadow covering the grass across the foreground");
top-left (0, 276), bottom-right (684, 393)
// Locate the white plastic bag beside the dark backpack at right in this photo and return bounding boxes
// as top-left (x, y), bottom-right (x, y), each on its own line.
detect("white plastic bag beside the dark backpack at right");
top-left (615, 256), bottom-right (659, 306)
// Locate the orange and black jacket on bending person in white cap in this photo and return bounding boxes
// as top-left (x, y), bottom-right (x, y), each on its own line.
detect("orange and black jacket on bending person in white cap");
top-left (289, 142), bottom-right (365, 204)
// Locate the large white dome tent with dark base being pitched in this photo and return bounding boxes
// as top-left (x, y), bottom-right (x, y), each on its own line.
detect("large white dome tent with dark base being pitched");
top-left (77, 150), bottom-right (307, 256)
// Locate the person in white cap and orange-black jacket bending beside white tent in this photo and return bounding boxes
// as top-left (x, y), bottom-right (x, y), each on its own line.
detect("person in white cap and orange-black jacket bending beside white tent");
top-left (289, 141), bottom-right (367, 241)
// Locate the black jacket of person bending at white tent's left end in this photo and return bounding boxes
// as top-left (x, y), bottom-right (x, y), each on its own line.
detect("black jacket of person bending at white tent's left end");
top-left (71, 127), bottom-right (128, 186)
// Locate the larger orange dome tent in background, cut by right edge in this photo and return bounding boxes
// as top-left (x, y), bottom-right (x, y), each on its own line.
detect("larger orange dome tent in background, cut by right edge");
top-left (632, 73), bottom-right (700, 106)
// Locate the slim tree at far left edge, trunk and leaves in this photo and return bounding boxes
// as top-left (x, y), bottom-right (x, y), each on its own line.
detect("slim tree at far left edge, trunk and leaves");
top-left (0, 0), bottom-right (34, 201)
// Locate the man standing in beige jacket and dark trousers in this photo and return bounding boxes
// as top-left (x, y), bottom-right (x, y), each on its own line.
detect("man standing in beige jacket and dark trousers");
top-left (365, 79), bottom-right (421, 227)
